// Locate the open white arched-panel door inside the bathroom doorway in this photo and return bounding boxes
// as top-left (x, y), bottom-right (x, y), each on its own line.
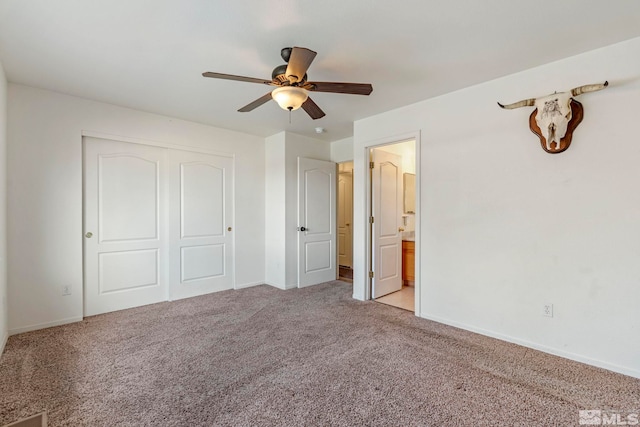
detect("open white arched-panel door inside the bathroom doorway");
top-left (371, 149), bottom-right (402, 299)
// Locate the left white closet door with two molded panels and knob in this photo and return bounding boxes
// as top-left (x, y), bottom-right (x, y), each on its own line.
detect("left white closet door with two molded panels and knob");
top-left (84, 137), bottom-right (167, 316)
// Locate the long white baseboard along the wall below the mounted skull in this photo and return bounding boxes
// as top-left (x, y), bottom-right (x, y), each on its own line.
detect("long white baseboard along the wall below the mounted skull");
top-left (420, 313), bottom-right (640, 379)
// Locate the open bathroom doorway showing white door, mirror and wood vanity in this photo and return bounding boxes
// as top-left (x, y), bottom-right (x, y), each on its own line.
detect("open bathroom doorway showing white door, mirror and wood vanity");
top-left (369, 139), bottom-right (416, 312)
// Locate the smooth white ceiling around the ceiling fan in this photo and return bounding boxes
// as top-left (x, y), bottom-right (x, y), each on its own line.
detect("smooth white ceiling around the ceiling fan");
top-left (0, 0), bottom-right (640, 141)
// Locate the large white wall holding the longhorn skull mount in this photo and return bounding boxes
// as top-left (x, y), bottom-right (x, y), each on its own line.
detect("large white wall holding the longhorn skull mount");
top-left (354, 38), bottom-right (640, 377)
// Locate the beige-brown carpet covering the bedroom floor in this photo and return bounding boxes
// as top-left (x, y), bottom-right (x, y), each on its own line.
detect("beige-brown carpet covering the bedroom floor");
top-left (0, 282), bottom-right (640, 426)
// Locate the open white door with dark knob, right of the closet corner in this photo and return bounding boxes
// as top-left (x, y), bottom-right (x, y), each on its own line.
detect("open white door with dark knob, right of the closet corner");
top-left (298, 157), bottom-right (337, 287)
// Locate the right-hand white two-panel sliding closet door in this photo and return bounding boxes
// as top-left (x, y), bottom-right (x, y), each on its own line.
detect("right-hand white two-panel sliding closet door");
top-left (168, 150), bottom-right (234, 299)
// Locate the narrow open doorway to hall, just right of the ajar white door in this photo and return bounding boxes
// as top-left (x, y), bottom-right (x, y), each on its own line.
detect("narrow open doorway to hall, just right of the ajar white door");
top-left (336, 161), bottom-right (353, 283)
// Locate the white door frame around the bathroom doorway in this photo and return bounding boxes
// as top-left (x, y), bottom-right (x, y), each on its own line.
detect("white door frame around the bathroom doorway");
top-left (364, 131), bottom-right (422, 316)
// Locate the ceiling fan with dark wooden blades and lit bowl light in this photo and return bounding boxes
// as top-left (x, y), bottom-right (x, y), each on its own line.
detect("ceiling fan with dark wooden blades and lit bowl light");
top-left (202, 47), bottom-right (373, 120)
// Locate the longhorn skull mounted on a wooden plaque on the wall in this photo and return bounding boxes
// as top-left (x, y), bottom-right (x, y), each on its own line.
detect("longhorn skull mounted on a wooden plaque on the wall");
top-left (498, 81), bottom-right (609, 154)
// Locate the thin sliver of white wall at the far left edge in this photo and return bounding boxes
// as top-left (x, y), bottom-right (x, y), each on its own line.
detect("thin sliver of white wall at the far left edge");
top-left (0, 63), bottom-right (9, 355)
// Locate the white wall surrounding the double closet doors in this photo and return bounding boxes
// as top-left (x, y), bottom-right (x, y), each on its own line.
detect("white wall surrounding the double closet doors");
top-left (7, 84), bottom-right (265, 333)
